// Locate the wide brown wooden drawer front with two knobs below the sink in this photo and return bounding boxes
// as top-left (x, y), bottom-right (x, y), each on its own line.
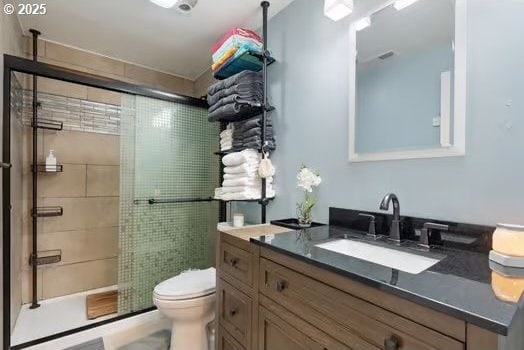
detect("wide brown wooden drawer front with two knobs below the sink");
top-left (260, 258), bottom-right (464, 350)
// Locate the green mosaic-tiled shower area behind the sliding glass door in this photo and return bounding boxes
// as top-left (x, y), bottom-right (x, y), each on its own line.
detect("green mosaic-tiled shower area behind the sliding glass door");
top-left (118, 96), bottom-right (219, 313)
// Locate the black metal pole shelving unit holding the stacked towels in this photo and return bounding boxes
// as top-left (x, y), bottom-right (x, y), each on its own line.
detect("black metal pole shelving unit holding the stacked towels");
top-left (215, 1), bottom-right (276, 224)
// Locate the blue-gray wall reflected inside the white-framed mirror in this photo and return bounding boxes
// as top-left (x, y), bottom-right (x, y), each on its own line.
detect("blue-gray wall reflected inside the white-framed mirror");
top-left (356, 43), bottom-right (453, 153)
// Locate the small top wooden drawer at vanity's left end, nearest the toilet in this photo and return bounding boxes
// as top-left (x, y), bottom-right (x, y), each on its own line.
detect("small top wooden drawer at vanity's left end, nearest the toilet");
top-left (218, 242), bottom-right (253, 287)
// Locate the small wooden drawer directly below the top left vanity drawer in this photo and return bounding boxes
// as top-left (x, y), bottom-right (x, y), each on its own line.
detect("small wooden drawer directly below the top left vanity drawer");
top-left (218, 280), bottom-right (253, 348)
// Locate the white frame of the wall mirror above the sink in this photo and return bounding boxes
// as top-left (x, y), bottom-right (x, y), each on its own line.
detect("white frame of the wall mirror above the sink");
top-left (349, 0), bottom-right (468, 162)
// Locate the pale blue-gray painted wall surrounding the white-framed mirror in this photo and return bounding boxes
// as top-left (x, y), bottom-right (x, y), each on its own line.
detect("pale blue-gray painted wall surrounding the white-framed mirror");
top-left (238, 0), bottom-right (524, 224)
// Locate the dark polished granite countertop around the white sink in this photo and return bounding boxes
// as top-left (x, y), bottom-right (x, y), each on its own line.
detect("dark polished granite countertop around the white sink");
top-left (251, 225), bottom-right (524, 335)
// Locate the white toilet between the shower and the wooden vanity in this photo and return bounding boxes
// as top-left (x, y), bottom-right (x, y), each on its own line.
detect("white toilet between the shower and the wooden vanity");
top-left (153, 267), bottom-right (216, 350)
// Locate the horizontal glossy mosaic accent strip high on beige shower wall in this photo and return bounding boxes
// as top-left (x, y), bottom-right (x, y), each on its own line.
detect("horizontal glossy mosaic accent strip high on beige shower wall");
top-left (23, 90), bottom-right (121, 135)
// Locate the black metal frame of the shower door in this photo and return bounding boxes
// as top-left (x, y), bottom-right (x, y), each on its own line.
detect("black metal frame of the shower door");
top-left (1, 55), bottom-right (220, 350)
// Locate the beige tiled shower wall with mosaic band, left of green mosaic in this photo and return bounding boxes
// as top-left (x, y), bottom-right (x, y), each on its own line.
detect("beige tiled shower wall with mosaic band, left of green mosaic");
top-left (22, 79), bottom-right (124, 302)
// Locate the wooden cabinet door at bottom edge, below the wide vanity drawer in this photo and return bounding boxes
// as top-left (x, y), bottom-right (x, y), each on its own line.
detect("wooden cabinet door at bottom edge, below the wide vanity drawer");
top-left (258, 307), bottom-right (352, 350)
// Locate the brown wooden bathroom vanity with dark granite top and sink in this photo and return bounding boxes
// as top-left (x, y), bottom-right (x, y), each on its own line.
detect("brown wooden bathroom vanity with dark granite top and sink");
top-left (216, 208), bottom-right (524, 350)
